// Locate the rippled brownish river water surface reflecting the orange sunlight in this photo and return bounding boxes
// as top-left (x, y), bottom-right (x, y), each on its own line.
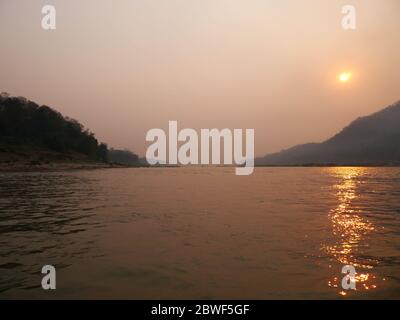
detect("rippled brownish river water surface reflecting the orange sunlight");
top-left (0, 167), bottom-right (400, 299)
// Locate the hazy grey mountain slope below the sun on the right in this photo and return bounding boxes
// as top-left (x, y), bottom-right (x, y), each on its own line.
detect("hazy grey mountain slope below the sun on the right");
top-left (255, 101), bottom-right (400, 166)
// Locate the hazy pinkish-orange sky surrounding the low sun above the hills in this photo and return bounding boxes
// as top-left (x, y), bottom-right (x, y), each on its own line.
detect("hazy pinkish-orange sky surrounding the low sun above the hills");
top-left (0, 0), bottom-right (400, 155)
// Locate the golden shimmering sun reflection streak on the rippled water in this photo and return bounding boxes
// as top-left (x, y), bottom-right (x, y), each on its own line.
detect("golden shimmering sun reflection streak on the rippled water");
top-left (323, 168), bottom-right (377, 296)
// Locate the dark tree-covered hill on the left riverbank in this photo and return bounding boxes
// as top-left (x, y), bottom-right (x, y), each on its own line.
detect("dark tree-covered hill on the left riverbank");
top-left (0, 93), bottom-right (108, 161)
